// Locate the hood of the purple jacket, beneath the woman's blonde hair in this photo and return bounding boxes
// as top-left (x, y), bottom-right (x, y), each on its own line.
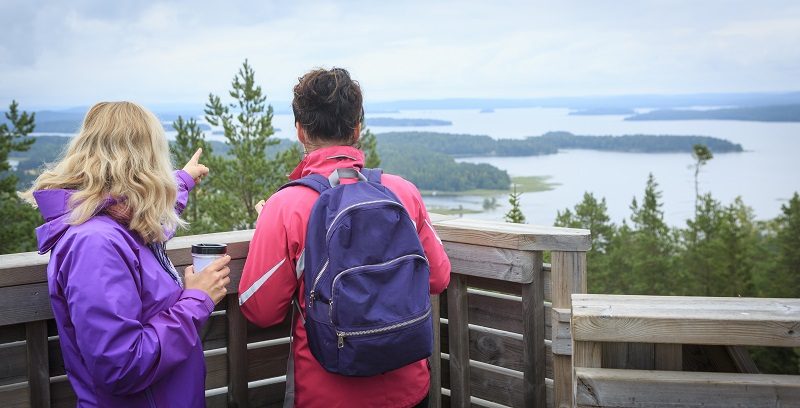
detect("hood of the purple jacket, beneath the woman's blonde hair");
top-left (33, 189), bottom-right (116, 254)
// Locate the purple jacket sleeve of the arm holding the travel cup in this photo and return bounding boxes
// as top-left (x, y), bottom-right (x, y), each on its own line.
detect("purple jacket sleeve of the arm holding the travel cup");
top-left (59, 234), bottom-right (214, 395)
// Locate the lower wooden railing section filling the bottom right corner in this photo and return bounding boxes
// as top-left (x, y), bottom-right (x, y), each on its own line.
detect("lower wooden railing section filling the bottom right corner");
top-left (572, 294), bottom-right (800, 407)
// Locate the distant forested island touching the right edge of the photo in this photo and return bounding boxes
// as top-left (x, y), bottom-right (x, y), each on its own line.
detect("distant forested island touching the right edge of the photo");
top-left (625, 105), bottom-right (800, 122)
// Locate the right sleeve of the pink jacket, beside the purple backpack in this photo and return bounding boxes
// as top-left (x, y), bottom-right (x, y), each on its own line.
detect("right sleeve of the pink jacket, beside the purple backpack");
top-left (409, 183), bottom-right (450, 295)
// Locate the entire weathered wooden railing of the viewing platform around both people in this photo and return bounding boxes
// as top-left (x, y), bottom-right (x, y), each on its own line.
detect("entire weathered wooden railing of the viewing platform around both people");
top-left (0, 217), bottom-right (800, 408)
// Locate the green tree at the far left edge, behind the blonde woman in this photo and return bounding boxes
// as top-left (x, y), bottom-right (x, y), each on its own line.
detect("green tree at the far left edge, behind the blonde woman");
top-left (0, 101), bottom-right (42, 254)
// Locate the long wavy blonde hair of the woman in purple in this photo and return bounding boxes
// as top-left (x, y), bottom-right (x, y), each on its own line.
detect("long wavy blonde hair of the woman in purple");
top-left (24, 102), bottom-right (185, 242)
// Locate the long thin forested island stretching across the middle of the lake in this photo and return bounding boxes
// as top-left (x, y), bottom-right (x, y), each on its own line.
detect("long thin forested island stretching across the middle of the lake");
top-left (377, 132), bottom-right (742, 157)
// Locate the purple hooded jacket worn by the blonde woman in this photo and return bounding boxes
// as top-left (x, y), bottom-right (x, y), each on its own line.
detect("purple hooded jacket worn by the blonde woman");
top-left (34, 171), bottom-right (214, 408)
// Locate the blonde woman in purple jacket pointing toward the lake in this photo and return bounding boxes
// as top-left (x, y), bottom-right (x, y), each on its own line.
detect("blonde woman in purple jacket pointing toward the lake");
top-left (26, 102), bottom-right (230, 408)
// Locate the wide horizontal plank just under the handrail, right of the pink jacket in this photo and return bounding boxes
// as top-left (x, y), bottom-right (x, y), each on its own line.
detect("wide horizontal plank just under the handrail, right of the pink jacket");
top-left (444, 242), bottom-right (533, 283)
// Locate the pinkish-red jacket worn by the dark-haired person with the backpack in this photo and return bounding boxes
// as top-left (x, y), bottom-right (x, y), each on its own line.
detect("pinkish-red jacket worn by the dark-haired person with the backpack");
top-left (239, 146), bottom-right (450, 408)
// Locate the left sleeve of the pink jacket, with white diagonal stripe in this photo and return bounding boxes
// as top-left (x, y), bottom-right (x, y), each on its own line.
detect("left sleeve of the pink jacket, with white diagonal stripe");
top-left (239, 190), bottom-right (301, 327)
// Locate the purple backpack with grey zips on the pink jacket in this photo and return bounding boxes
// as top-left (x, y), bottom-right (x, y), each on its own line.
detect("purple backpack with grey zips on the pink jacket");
top-left (282, 168), bottom-right (433, 376)
